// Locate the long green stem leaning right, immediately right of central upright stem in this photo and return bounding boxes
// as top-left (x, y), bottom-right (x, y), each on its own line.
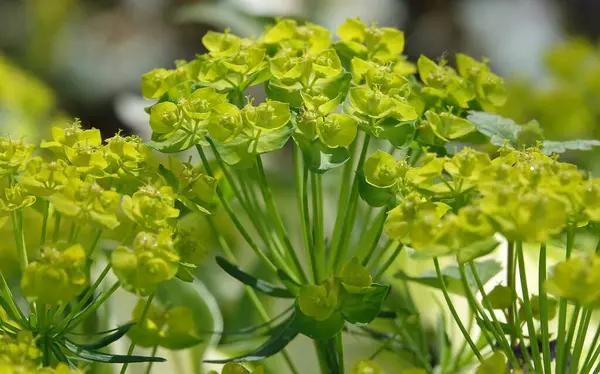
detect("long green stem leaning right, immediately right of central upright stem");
top-left (329, 135), bottom-right (371, 273)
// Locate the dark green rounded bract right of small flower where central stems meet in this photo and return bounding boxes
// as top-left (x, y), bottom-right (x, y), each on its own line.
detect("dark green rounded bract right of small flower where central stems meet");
top-left (340, 283), bottom-right (390, 325)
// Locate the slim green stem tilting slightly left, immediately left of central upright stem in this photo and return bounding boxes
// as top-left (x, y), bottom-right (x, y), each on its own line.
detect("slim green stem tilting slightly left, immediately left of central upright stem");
top-left (292, 142), bottom-right (319, 284)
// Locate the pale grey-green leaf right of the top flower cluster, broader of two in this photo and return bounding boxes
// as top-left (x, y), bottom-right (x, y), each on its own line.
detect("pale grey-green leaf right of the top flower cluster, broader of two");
top-left (467, 111), bottom-right (521, 147)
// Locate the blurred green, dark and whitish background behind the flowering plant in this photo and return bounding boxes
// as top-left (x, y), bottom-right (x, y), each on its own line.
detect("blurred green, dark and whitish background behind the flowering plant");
top-left (0, 0), bottom-right (600, 373)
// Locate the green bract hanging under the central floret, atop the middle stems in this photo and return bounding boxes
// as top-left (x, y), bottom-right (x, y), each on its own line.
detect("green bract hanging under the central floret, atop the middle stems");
top-left (294, 136), bottom-right (350, 174)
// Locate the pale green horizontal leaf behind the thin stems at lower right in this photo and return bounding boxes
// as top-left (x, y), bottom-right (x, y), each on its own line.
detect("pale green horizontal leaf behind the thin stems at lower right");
top-left (395, 260), bottom-right (502, 296)
